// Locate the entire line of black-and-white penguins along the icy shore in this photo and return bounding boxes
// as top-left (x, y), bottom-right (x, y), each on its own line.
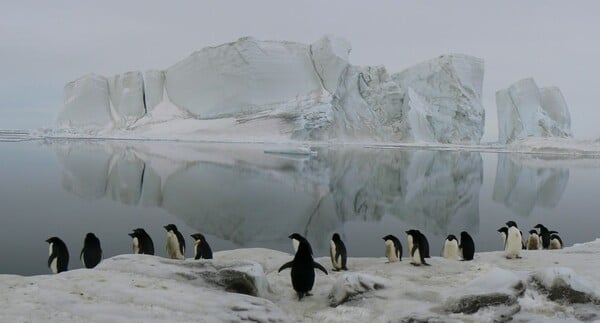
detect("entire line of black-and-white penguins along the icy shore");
top-left (46, 221), bottom-right (563, 300)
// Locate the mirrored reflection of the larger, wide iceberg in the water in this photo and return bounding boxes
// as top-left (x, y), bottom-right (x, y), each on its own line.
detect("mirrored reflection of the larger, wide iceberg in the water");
top-left (51, 141), bottom-right (483, 254)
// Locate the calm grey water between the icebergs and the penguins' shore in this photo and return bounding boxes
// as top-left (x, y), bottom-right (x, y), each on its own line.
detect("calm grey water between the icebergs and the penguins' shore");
top-left (0, 141), bottom-right (600, 275)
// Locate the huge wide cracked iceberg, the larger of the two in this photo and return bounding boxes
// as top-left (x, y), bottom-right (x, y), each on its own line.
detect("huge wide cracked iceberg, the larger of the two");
top-left (57, 36), bottom-right (484, 143)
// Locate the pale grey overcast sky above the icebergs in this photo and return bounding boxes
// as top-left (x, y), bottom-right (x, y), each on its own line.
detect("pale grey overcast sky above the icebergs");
top-left (0, 0), bottom-right (600, 141)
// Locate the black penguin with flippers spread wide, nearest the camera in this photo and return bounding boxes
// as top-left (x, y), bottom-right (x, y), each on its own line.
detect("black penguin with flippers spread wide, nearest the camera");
top-left (278, 233), bottom-right (327, 300)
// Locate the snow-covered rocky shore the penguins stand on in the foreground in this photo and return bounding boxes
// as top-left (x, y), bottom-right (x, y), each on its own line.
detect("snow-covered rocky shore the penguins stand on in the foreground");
top-left (0, 239), bottom-right (600, 322)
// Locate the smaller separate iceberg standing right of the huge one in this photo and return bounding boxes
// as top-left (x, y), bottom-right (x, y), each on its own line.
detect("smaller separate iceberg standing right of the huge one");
top-left (496, 78), bottom-right (572, 143)
